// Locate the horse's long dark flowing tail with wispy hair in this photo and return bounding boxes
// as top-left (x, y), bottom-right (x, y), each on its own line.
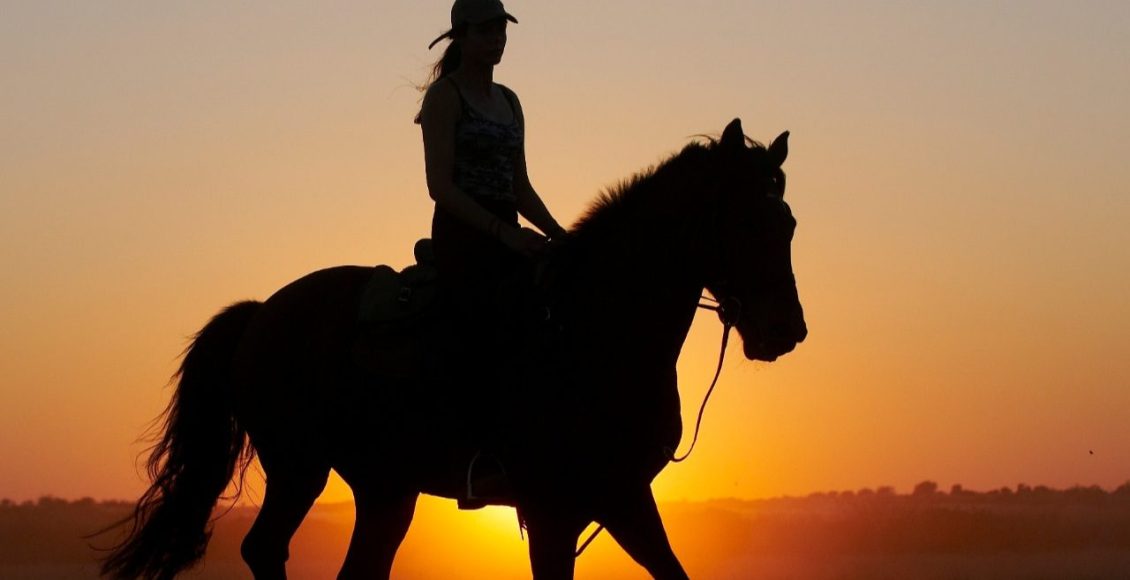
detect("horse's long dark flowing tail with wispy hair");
top-left (102, 301), bottom-right (262, 579)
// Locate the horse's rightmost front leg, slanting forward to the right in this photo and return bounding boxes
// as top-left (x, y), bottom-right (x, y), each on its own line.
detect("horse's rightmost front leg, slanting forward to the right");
top-left (597, 486), bottom-right (687, 580)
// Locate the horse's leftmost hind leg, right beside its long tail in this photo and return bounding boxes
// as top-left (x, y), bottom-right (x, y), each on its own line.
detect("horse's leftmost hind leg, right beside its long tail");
top-left (240, 464), bottom-right (330, 580)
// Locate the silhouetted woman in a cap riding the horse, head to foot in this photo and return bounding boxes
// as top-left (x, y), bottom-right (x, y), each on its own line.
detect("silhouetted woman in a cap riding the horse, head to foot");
top-left (416, 0), bottom-right (565, 506)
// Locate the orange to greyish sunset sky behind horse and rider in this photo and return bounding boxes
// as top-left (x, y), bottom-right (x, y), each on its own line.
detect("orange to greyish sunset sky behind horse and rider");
top-left (0, 0), bottom-right (1130, 500)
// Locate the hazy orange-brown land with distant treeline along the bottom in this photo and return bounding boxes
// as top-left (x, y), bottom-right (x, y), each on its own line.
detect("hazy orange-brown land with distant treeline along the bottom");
top-left (0, 482), bottom-right (1130, 578)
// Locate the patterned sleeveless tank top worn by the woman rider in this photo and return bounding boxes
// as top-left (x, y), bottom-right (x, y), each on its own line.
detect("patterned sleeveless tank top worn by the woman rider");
top-left (451, 79), bottom-right (523, 204)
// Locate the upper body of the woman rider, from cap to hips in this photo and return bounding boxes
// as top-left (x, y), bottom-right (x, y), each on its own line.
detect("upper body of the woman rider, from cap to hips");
top-left (417, 0), bottom-right (564, 279)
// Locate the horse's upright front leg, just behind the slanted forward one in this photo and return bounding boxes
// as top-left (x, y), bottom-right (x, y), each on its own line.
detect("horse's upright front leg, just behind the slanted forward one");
top-left (521, 501), bottom-right (588, 580)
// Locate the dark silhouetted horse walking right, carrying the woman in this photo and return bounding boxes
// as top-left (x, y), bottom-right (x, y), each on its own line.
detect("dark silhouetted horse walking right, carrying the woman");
top-left (103, 119), bottom-right (808, 580)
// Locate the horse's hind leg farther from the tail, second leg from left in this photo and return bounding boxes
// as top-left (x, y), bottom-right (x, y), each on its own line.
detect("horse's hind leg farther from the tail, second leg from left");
top-left (338, 486), bottom-right (418, 580)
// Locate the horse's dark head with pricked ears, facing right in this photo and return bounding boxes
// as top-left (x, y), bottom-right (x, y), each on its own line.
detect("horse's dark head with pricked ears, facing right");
top-left (706, 120), bottom-right (808, 361)
